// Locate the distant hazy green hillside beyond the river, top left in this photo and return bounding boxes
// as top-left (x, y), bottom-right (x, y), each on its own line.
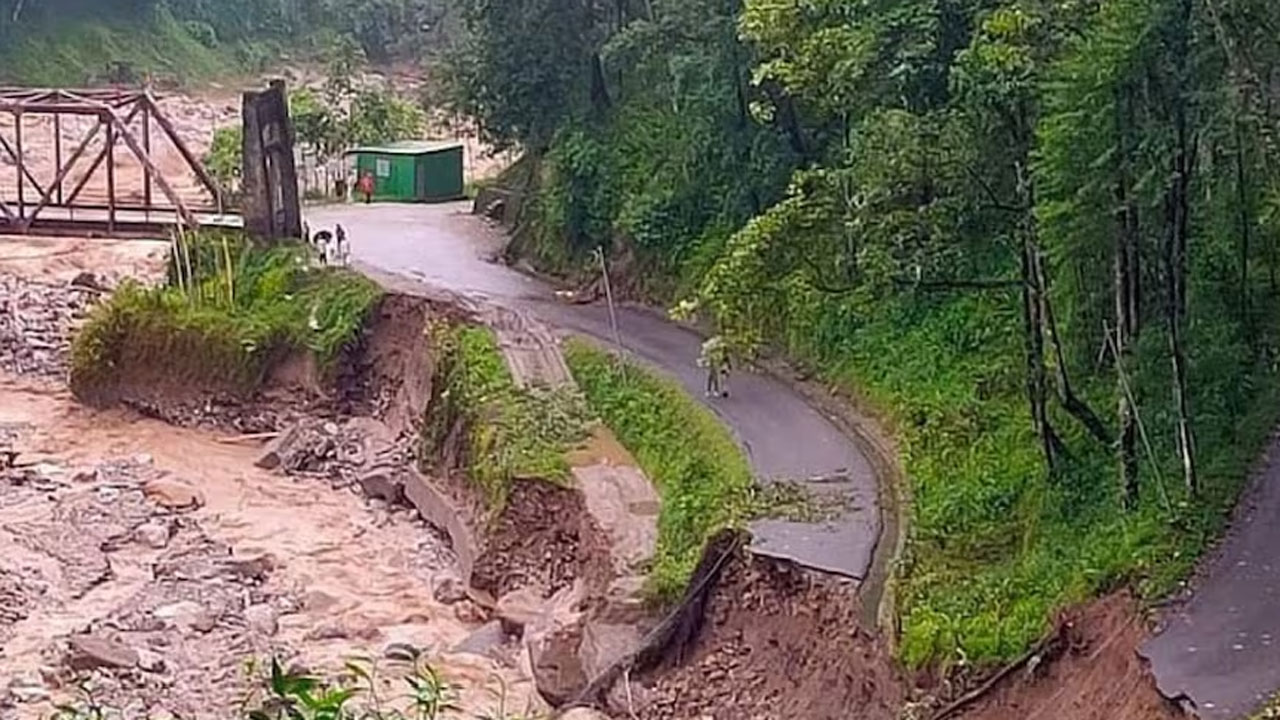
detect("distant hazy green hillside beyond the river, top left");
top-left (0, 0), bottom-right (451, 85)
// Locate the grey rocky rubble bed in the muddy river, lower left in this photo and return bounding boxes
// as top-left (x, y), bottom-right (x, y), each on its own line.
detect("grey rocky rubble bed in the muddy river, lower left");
top-left (0, 456), bottom-right (301, 717)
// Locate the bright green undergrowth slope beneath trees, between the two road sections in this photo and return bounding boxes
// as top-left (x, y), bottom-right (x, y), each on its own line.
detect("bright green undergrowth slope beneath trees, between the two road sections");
top-left (787, 286), bottom-right (1280, 666)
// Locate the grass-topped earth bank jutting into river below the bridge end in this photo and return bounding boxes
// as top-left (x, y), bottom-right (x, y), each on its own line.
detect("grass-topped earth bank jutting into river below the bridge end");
top-left (70, 233), bottom-right (381, 397)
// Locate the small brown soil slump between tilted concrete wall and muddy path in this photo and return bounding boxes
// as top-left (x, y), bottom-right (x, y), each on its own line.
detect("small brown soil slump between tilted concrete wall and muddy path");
top-left (471, 480), bottom-right (612, 597)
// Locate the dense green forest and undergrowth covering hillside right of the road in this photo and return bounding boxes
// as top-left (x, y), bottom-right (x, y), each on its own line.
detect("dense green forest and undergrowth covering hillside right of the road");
top-left (451, 0), bottom-right (1280, 666)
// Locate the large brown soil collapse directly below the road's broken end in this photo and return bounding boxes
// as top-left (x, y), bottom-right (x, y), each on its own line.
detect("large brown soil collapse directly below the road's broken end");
top-left (624, 553), bottom-right (904, 720)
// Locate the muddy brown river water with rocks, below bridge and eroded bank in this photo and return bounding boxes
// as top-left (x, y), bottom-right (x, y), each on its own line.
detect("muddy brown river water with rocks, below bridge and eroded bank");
top-left (0, 241), bottom-right (544, 719)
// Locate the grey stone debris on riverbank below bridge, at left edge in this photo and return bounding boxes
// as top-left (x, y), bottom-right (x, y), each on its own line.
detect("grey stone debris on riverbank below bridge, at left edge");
top-left (0, 273), bottom-right (100, 378)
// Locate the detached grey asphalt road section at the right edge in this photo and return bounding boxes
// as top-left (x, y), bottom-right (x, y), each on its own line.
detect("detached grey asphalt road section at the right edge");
top-left (1142, 442), bottom-right (1280, 720)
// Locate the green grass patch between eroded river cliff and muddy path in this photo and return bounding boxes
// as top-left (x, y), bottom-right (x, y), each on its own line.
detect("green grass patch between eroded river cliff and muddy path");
top-left (424, 324), bottom-right (590, 516)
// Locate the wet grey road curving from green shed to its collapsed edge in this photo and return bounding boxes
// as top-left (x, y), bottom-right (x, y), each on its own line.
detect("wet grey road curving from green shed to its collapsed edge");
top-left (306, 204), bottom-right (881, 579)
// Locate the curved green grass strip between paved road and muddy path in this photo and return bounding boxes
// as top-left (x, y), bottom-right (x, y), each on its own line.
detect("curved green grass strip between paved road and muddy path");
top-left (566, 341), bottom-right (754, 598)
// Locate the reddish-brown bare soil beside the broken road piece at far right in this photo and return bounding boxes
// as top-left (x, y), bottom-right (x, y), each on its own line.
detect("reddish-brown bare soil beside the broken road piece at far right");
top-left (957, 593), bottom-right (1185, 720)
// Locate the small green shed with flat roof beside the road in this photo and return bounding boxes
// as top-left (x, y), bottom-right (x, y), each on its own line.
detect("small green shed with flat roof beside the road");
top-left (347, 140), bottom-right (465, 202)
